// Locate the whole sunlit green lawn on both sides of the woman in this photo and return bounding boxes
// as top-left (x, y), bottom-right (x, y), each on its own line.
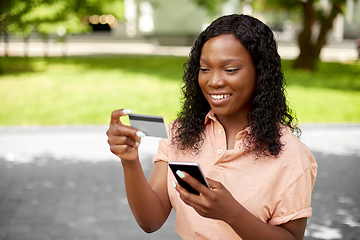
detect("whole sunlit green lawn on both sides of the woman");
top-left (0, 56), bottom-right (360, 125)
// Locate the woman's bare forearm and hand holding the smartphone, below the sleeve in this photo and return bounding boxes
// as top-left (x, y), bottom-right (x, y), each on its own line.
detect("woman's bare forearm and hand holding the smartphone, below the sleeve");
top-left (176, 173), bottom-right (306, 240)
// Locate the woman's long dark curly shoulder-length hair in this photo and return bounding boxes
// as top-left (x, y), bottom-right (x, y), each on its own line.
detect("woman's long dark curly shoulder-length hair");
top-left (172, 14), bottom-right (301, 156)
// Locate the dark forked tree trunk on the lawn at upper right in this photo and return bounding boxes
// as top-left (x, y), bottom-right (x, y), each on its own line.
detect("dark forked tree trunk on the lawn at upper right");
top-left (293, 0), bottom-right (346, 71)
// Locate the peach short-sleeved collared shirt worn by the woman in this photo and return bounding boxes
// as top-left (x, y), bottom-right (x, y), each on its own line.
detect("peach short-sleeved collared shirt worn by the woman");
top-left (153, 111), bottom-right (317, 239)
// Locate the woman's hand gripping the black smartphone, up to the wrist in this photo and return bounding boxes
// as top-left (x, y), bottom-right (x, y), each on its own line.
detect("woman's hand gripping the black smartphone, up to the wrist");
top-left (175, 172), bottom-right (239, 222)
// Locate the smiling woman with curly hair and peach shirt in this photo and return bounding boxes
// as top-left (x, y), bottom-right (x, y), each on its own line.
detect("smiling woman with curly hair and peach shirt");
top-left (108, 14), bottom-right (317, 240)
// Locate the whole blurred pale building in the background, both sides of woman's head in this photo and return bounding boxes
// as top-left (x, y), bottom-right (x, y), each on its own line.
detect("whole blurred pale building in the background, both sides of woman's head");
top-left (112, 0), bottom-right (360, 46)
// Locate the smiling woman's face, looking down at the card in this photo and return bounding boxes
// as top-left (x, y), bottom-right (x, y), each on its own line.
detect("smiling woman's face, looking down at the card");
top-left (198, 34), bottom-right (256, 120)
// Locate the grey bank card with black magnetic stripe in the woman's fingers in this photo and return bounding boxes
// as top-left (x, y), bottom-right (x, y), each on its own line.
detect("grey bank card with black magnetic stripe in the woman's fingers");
top-left (129, 113), bottom-right (168, 138)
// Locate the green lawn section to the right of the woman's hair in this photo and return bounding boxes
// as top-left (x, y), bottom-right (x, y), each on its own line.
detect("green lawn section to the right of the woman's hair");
top-left (283, 61), bottom-right (360, 123)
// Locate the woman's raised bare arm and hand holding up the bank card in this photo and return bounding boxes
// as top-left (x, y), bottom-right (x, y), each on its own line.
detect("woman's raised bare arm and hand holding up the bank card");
top-left (107, 110), bottom-right (171, 233)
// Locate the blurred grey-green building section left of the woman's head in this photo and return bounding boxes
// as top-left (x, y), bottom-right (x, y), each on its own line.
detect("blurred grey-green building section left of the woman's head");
top-left (113, 0), bottom-right (208, 45)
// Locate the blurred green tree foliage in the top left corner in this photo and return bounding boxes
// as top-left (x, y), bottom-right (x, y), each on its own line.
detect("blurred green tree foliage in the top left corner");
top-left (0, 0), bottom-right (124, 56)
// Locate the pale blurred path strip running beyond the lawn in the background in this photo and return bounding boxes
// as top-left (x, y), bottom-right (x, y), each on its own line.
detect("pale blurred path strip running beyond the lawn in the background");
top-left (0, 35), bottom-right (358, 61)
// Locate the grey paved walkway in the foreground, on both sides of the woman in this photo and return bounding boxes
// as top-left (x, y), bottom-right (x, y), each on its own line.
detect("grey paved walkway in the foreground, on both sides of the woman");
top-left (0, 124), bottom-right (360, 240)
